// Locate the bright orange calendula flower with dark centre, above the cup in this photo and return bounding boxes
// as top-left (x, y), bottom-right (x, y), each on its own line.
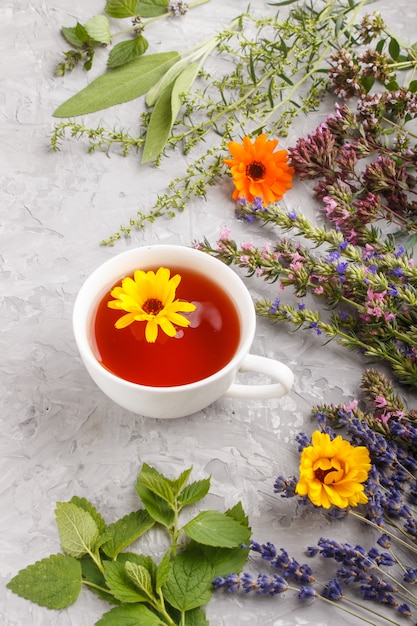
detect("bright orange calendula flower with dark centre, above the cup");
top-left (224, 133), bottom-right (294, 205)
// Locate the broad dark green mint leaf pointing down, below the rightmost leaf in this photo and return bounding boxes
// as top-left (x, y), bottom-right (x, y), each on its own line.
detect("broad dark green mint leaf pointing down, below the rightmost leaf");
top-left (162, 552), bottom-right (213, 611)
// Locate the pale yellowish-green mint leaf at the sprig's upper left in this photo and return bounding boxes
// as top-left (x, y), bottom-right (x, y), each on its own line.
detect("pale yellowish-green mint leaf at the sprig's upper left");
top-left (55, 502), bottom-right (99, 558)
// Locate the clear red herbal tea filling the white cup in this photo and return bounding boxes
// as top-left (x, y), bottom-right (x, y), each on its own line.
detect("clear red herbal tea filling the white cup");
top-left (93, 267), bottom-right (240, 387)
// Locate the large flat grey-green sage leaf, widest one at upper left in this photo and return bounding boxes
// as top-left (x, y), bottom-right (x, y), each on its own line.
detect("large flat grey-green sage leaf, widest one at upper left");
top-left (53, 52), bottom-right (180, 117)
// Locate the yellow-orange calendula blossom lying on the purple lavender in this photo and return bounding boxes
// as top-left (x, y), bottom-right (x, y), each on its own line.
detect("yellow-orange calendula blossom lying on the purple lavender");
top-left (295, 430), bottom-right (371, 509)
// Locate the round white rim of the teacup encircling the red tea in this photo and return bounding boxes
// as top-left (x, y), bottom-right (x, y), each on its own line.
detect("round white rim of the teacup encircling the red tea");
top-left (72, 244), bottom-right (256, 394)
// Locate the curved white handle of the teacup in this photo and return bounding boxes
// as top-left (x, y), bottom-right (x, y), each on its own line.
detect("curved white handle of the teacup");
top-left (224, 354), bottom-right (294, 398)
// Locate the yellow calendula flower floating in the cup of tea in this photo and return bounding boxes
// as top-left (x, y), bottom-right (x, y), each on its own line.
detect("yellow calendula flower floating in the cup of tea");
top-left (107, 267), bottom-right (196, 343)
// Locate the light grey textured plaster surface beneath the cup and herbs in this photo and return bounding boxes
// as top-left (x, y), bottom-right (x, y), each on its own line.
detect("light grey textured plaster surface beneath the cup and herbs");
top-left (0, 0), bottom-right (416, 626)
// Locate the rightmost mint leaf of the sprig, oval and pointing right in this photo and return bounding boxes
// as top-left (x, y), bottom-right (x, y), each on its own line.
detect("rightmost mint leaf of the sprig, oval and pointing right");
top-left (183, 511), bottom-right (248, 548)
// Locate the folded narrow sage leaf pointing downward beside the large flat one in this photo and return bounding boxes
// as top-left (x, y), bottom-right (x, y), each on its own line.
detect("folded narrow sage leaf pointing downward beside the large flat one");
top-left (142, 63), bottom-right (199, 163)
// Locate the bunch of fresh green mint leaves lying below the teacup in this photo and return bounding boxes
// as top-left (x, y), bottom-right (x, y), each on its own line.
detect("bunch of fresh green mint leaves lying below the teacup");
top-left (7, 463), bottom-right (250, 626)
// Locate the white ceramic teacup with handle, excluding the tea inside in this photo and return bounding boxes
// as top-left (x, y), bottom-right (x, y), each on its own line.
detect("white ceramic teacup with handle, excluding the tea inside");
top-left (73, 245), bottom-right (294, 419)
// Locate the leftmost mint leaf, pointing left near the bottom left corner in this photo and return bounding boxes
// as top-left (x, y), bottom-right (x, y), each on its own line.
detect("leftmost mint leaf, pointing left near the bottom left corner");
top-left (7, 554), bottom-right (82, 609)
